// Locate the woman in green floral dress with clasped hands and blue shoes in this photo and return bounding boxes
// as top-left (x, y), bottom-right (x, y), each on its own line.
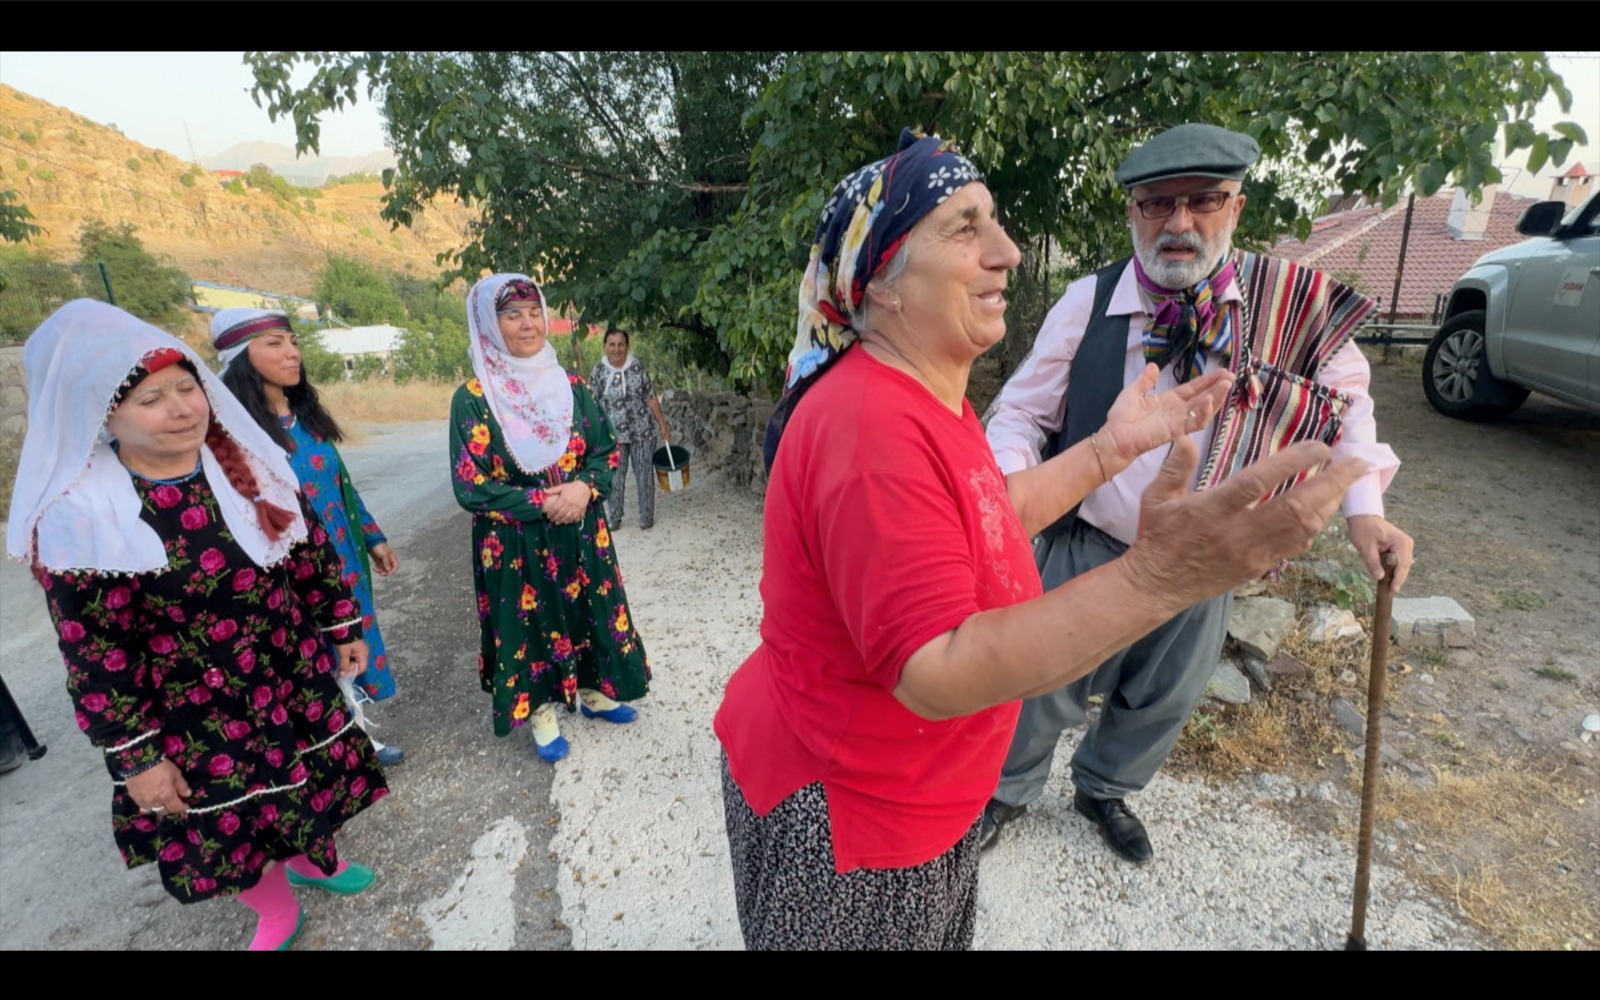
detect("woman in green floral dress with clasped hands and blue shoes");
top-left (450, 274), bottom-right (650, 762)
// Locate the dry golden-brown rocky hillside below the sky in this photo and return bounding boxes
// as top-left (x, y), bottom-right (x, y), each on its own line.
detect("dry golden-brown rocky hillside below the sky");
top-left (0, 85), bottom-right (474, 296)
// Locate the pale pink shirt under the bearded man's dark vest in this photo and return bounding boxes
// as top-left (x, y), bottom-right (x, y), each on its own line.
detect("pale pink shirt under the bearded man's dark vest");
top-left (987, 252), bottom-right (1400, 544)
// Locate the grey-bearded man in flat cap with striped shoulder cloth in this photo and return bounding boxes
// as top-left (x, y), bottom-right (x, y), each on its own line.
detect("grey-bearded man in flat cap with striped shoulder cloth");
top-left (982, 123), bottom-right (1411, 864)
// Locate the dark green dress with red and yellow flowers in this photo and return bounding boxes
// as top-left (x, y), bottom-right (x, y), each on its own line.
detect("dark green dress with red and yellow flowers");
top-left (450, 376), bottom-right (650, 736)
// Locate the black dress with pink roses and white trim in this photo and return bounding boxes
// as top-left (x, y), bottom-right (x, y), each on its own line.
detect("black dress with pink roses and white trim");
top-left (38, 470), bottom-right (389, 902)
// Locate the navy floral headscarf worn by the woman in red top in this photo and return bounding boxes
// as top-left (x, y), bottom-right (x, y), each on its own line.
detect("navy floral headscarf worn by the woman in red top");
top-left (763, 128), bottom-right (982, 472)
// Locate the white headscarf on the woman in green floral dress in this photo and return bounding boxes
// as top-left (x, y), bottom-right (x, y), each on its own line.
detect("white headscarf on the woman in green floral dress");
top-left (467, 274), bottom-right (573, 474)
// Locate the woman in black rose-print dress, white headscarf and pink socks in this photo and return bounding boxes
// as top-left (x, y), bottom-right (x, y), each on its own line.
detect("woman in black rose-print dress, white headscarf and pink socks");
top-left (6, 299), bottom-right (387, 950)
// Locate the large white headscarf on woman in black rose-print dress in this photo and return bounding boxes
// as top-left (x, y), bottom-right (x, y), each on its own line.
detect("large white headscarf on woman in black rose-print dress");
top-left (6, 299), bottom-right (306, 573)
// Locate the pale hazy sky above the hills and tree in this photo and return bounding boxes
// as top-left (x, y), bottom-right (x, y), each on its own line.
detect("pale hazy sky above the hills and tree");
top-left (0, 51), bottom-right (1600, 197)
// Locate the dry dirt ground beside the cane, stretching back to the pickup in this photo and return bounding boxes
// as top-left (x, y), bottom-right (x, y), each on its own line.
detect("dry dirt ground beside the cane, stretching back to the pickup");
top-left (1222, 350), bottom-right (1600, 949)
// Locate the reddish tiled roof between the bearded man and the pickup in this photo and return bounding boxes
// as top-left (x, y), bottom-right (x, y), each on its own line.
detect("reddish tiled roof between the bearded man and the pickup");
top-left (1272, 190), bottom-right (1538, 318)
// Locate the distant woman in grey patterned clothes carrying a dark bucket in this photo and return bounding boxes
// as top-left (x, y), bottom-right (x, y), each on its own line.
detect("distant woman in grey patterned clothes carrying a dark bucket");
top-left (589, 326), bottom-right (672, 531)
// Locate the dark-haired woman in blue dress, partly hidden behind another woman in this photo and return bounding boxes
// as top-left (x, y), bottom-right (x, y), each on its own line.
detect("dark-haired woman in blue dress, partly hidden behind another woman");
top-left (211, 309), bottom-right (405, 766)
